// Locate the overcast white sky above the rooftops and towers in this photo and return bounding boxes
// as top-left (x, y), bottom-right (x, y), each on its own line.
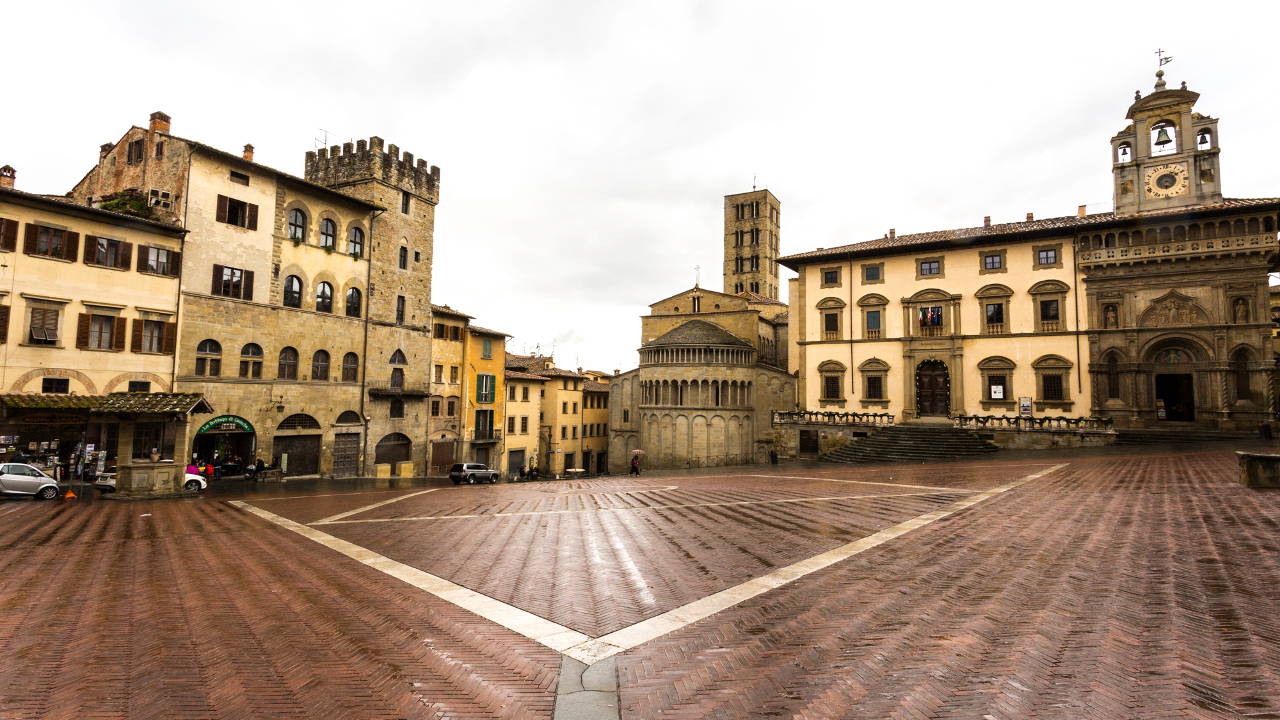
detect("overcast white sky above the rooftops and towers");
top-left (0, 0), bottom-right (1280, 370)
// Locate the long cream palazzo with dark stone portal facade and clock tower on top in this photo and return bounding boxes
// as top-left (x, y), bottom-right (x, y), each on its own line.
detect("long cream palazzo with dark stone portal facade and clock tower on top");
top-left (780, 73), bottom-right (1280, 429)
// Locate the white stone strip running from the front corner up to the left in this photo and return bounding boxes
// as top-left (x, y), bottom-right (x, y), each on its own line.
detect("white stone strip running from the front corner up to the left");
top-left (229, 500), bottom-right (591, 652)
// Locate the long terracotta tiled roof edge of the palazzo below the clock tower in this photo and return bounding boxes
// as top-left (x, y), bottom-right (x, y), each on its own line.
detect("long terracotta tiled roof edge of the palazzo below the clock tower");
top-left (778, 197), bottom-right (1280, 270)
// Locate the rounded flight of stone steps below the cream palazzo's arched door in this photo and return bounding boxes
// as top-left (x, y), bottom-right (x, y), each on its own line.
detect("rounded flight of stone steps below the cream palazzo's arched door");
top-left (819, 424), bottom-right (998, 464)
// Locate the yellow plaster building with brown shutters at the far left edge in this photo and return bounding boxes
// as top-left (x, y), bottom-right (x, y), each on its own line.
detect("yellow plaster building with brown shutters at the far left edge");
top-left (0, 176), bottom-right (186, 395)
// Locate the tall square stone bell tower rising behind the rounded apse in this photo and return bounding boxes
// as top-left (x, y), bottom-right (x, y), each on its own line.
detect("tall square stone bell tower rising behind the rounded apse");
top-left (724, 190), bottom-right (782, 300)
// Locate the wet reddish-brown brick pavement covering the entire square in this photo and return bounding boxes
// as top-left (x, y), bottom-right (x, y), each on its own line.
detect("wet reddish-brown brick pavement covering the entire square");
top-left (0, 448), bottom-right (1280, 720)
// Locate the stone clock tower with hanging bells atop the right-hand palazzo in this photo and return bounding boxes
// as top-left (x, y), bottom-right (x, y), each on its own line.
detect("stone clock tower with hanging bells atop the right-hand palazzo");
top-left (1111, 70), bottom-right (1222, 215)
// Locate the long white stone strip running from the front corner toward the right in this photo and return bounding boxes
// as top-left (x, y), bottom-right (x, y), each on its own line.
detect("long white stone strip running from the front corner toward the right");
top-left (561, 462), bottom-right (1068, 665)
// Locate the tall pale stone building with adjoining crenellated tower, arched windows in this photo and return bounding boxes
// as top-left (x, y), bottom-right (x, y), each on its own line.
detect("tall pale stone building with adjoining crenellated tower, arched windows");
top-left (70, 113), bottom-right (439, 475)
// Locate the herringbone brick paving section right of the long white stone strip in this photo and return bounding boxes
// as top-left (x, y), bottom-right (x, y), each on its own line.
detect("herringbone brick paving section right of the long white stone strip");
top-left (618, 452), bottom-right (1280, 719)
